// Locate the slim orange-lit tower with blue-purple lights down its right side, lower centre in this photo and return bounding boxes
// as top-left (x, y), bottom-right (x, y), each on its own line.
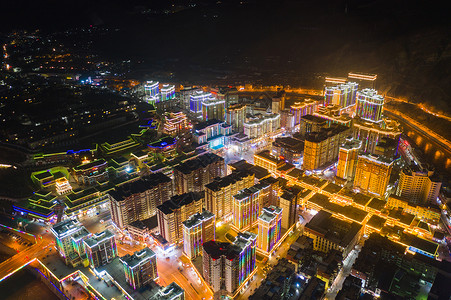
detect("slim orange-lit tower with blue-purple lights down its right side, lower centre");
top-left (257, 206), bottom-right (282, 253)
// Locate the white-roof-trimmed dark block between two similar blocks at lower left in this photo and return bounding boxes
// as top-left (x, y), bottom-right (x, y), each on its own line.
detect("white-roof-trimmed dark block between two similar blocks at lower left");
top-left (83, 229), bottom-right (117, 268)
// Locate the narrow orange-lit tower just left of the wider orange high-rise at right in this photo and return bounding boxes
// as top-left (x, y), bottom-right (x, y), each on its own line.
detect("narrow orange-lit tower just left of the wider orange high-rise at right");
top-left (337, 138), bottom-right (362, 181)
